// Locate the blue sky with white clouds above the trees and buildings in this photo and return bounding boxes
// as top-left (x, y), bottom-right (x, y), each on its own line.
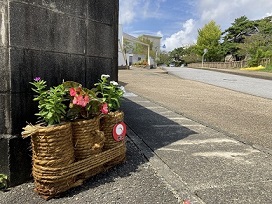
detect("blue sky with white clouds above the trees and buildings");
top-left (119, 0), bottom-right (272, 51)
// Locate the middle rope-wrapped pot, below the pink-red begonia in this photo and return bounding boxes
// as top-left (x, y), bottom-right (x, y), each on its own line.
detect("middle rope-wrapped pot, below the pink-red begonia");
top-left (72, 117), bottom-right (105, 179)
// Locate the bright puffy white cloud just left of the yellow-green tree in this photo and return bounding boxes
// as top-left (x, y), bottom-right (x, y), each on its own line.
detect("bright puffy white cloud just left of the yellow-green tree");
top-left (162, 19), bottom-right (196, 51)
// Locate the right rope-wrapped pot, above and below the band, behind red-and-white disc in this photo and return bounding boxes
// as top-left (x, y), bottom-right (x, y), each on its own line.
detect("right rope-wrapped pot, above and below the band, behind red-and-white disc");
top-left (100, 111), bottom-right (126, 168)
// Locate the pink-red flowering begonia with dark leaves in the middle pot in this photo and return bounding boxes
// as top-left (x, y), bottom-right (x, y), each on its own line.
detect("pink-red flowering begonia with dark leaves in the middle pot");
top-left (63, 81), bottom-right (108, 120)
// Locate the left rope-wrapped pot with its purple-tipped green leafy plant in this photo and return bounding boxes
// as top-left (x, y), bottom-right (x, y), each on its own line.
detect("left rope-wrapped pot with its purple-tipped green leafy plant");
top-left (22, 77), bottom-right (75, 197)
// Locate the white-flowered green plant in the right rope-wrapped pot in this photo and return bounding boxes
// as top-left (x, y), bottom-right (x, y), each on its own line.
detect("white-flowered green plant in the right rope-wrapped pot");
top-left (93, 74), bottom-right (125, 111)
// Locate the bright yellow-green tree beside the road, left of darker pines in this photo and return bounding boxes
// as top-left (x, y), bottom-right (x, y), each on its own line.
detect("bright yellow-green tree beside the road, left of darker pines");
top-left (195, 20), bottom-right (223, 62)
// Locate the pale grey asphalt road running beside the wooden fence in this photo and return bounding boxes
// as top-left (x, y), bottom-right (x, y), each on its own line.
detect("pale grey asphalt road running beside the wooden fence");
top-left (164, 67), bottom-right (272, 99)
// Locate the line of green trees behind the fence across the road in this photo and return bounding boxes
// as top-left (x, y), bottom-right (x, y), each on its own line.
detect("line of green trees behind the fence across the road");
top-left (170, 16), bottom-right (272, 65)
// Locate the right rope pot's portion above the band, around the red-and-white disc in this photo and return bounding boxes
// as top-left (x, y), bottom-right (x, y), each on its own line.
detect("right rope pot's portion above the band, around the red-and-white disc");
top-left (101, 111), bottom-right (124, 149)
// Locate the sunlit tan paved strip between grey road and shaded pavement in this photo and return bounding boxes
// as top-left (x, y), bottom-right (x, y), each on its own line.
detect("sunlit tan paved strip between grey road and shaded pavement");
top-left (119, 68), bottom-right (272, 152)
